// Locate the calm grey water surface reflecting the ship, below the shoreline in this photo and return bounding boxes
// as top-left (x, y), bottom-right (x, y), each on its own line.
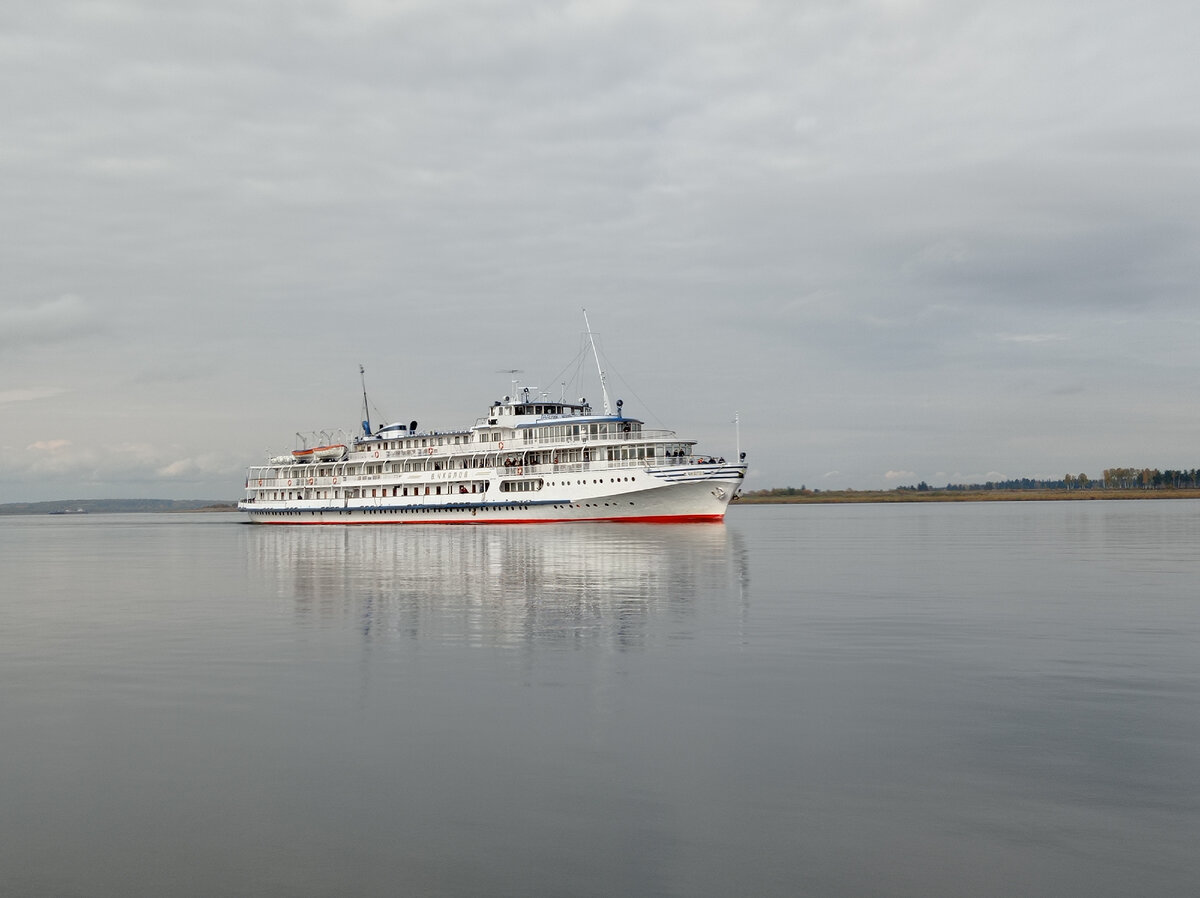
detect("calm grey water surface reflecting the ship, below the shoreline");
top-left (0, 501), bottom-right (1200, 897)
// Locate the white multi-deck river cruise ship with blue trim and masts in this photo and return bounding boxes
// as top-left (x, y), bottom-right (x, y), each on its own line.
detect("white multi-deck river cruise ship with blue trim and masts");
top-left (238, 321), bottom-right (746, 523)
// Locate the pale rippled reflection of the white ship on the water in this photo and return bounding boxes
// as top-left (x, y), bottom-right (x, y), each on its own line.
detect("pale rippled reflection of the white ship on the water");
top-left (250, 523), bottom-right (749, 649)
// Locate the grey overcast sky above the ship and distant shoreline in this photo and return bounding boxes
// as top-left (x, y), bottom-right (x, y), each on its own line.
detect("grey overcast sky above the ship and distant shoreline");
top-left (0, 0), bottom-right (1200, 502)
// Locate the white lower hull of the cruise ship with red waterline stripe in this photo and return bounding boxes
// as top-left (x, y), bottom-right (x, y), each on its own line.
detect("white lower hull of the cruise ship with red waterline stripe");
top-left (240, 465), bottom-right (745, 525)
